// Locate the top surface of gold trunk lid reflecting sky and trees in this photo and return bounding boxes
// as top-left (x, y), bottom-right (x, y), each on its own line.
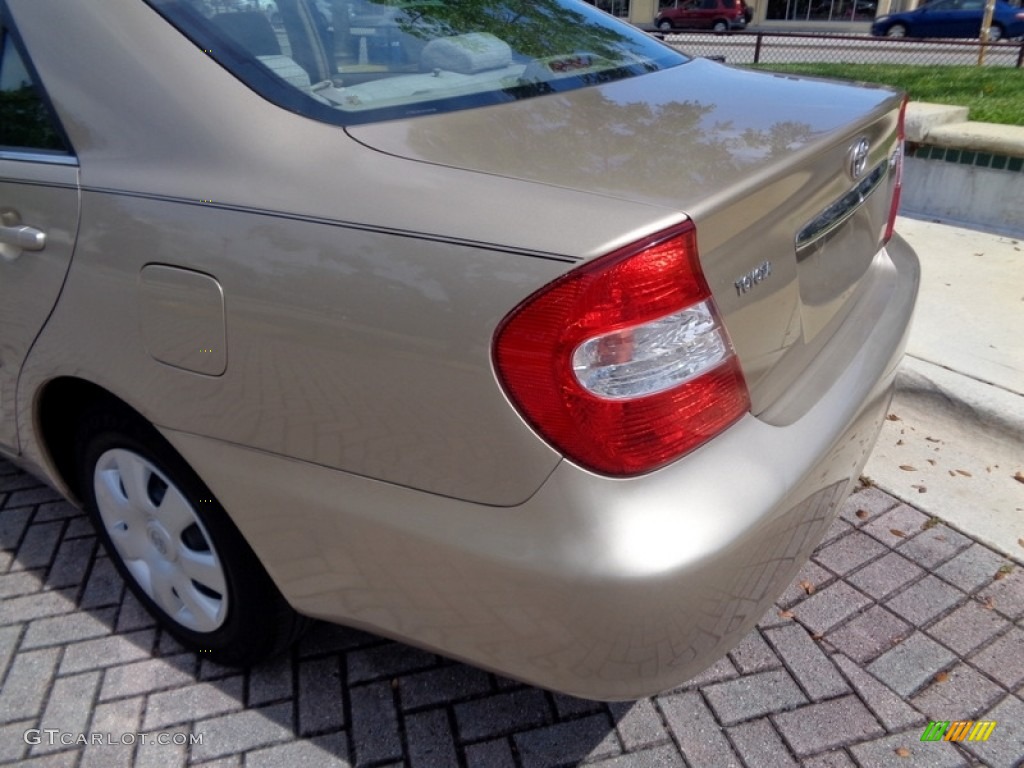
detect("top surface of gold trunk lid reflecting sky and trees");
top-left (349, 60), bottom-right (888, 206)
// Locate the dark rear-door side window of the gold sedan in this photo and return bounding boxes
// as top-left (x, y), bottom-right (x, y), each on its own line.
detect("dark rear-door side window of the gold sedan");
top-left (0, 27), bottom-right (68, 152)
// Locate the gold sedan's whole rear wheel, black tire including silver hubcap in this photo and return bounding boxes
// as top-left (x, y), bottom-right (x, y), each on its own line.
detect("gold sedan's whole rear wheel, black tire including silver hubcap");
top-left (76, 410), bottom-right (307, 666)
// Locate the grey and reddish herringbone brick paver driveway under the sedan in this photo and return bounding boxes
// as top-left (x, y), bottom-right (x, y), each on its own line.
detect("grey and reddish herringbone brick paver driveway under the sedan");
top-left (0, 462), bottom-right (1024, 768)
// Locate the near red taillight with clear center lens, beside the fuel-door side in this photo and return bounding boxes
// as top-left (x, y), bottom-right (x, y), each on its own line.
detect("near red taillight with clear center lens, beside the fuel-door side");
top-left (495, 223), bottom-right (750, 475)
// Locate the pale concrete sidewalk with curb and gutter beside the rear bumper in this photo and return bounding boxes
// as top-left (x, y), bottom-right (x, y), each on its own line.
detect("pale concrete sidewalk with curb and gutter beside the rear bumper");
top-left (864, 217), bottom-right (1024, 561)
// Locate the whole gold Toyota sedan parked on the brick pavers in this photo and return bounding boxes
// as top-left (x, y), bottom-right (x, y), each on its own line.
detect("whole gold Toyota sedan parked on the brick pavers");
top-left (0, 0), bottom-right (919, 698)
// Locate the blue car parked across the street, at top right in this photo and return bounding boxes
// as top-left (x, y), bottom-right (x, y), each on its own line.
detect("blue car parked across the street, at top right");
top-left (871, 0), bottom-right (1024, 40)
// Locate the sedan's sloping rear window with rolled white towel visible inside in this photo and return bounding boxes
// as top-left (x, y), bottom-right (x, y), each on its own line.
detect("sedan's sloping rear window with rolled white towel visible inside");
top-left (146, 0), bottom-right (687, 125)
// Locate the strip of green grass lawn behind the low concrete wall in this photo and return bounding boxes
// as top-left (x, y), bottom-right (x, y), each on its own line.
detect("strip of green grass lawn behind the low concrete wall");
top-left (757, 63), bottom-right (1024, 125)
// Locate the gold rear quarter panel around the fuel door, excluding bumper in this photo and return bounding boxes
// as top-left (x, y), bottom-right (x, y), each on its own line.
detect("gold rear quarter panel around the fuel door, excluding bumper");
top-left (10, 0), bottom-right (682, 505)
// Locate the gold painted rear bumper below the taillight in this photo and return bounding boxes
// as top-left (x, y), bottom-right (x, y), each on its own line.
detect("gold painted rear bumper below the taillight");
top-left (165, 239), bottom-right (919, 699)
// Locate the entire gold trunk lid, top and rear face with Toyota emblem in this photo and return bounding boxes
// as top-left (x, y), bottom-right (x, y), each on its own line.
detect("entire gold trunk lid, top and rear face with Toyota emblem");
top-left (347, 59), bottom-right (901, 423)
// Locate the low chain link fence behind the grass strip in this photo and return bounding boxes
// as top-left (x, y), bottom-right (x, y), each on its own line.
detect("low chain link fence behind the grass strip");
top-left (653, 32), bottom-right (1024, 69)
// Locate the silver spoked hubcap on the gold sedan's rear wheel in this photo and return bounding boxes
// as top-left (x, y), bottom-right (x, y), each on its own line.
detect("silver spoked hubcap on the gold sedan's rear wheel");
top-left (93, 449), bottom-right (227, 632)
